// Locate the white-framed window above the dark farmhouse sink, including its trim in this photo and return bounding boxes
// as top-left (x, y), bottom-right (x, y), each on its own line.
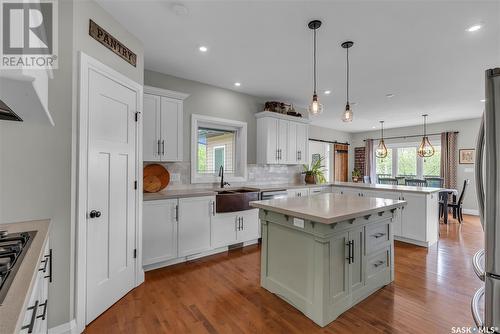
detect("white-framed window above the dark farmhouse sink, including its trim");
top-left (191, 115), bottom-right (247, 183)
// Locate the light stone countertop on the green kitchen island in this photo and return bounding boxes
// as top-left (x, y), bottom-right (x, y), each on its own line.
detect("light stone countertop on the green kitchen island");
top-left (250, 193), bottom-right (406, 224)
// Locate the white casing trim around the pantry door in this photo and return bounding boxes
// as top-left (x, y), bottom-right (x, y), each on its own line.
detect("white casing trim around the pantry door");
top-left (74, 52), bottom-right (144, 333)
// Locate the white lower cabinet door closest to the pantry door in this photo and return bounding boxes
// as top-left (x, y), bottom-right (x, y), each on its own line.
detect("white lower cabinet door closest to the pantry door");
top-left (142, 199), bottom-right (177, 265)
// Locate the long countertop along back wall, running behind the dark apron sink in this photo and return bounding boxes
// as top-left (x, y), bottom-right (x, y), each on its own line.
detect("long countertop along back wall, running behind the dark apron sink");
top-left (143, 183), bottom-right (332, 201)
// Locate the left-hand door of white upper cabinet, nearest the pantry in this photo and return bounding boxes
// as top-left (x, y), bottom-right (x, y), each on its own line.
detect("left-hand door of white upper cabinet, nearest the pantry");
top-left (142, 94), bottom-right (161, 161)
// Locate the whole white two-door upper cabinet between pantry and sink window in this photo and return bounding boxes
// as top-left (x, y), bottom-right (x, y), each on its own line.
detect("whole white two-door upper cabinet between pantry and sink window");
top-left (143, 86), bottom-right (189, 161)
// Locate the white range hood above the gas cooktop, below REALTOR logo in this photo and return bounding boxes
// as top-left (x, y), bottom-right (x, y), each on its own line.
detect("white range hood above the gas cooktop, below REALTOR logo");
top-left (0, 70), bottom-right (55, 126)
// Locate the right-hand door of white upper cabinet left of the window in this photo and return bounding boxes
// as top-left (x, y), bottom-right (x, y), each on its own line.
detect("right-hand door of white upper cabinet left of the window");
top-left (160, 97), bottom-right (183, 161)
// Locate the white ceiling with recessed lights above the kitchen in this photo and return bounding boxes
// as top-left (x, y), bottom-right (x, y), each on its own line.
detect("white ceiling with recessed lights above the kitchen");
top-left (98, 0), bottom-right (500, 132)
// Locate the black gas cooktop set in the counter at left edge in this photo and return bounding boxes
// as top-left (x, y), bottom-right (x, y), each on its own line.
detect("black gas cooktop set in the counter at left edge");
top-left (0, 231), bottom-right (36, 305)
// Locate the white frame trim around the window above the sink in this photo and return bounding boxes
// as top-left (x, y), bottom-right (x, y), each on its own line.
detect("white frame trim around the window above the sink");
top-left (191, 114), bottom-right (247, 183)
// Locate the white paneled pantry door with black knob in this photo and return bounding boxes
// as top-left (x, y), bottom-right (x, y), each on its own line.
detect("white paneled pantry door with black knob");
top-left (82, 69), bottom-right (138, 324)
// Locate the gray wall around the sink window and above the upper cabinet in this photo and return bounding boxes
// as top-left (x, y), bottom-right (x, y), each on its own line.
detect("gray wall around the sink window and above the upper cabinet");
top-left (144, 70), bottom-right (265, 164)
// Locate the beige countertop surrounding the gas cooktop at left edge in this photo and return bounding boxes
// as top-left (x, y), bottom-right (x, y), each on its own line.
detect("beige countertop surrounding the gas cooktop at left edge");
top-left (0, 220), bottom-right (50, 333)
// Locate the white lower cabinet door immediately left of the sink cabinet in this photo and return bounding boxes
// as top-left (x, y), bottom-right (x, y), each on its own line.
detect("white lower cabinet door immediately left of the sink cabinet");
top-left (178, 196), bottom-right (215, 256)
